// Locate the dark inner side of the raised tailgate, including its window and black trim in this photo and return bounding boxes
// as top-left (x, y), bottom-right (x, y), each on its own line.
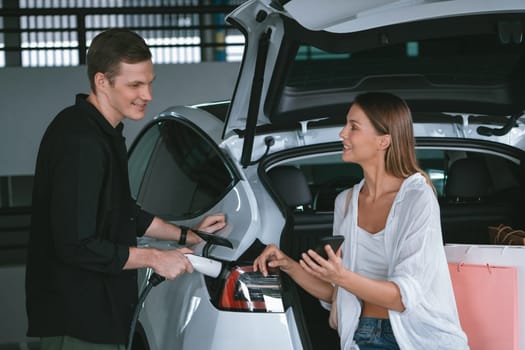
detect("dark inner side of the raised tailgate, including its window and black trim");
top-left (265, 15), bottom-right (525, 125)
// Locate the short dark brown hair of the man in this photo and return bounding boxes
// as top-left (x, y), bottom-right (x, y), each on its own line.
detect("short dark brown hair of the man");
top-left (87, 29), bottom-right (151, 92)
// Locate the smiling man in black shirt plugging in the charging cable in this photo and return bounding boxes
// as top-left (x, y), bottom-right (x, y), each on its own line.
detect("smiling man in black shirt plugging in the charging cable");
top-left (26, 29), bottom-right (225, 350)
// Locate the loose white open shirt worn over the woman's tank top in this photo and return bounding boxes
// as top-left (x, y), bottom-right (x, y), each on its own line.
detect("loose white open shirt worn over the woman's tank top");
top-left (333, 173), bottom-right (468, 350)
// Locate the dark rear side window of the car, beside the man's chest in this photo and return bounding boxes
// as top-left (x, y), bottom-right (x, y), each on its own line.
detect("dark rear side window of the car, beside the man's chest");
top-left (129, 119), bottom-right (235, 220)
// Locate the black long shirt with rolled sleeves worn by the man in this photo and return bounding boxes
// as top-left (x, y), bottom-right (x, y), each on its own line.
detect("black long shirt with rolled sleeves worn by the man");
top-left (26, 95), bottom-right (153, 344)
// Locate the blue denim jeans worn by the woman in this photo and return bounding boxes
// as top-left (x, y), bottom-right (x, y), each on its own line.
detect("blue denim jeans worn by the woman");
top-left (354, 317), bottom-right (399, 350)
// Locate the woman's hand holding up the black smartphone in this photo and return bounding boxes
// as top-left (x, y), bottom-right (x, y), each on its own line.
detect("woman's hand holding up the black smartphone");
top-left (299, 244), bottom-right (345, 285)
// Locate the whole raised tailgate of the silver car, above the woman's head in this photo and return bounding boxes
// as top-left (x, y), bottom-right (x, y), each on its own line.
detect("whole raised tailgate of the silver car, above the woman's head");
top-left (224, 0), bottom-right (525, 160)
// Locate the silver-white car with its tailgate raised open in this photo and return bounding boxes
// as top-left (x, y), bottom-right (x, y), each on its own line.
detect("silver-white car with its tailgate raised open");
top-left (129, 0), bottom-right (525, 350)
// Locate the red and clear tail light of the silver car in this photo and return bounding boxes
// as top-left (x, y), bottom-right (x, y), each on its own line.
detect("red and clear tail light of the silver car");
top-left (219, 266), bottom-right (284, 312)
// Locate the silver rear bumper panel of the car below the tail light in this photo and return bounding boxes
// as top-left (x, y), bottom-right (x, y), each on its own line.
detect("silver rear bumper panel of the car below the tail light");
top-left (137, 272), bottom-right (301, 350)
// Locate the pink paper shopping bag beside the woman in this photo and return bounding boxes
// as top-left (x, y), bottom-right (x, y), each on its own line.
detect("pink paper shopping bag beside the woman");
top-left (448, 263), bottom-right (519, 350)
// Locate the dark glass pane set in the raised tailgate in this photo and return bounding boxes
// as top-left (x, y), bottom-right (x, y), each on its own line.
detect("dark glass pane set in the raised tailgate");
top-left (286, 33), bottom-right (522, 90)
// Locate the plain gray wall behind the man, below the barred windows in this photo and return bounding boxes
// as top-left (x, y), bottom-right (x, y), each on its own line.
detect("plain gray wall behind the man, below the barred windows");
top-left (0, 62), bottom-right (239, 176)
